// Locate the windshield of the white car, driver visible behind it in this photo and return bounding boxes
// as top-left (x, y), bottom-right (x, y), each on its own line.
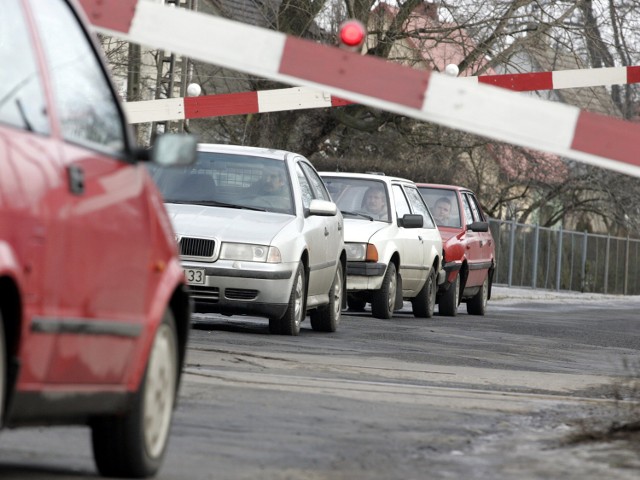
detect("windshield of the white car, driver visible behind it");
top-left (322, 176), bottom-right (390, 222)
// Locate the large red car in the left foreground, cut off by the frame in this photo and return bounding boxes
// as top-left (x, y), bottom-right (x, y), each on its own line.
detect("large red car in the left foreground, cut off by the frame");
top-left (0, 0), bottom-right (196, 477)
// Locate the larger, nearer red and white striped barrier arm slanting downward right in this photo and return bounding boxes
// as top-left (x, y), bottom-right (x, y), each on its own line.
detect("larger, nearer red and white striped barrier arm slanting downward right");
top-left (80, 0), bottom-right (640, 176)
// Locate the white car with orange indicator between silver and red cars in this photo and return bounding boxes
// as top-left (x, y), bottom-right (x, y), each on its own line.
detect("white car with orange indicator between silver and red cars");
top-left (320, 172), bottom-right (442, 319)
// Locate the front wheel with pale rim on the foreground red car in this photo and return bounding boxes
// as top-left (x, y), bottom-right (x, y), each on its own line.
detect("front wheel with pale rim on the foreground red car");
top-left (91, 310), bottom-right (179, 478)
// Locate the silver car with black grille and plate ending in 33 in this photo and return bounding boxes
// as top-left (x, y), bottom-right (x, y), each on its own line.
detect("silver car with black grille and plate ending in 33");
top-left (148, 144), bottom-right (346, 335)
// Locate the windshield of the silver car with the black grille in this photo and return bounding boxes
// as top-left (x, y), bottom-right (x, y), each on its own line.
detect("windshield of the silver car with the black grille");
top-left (150, 152), bottom-right (294, 214)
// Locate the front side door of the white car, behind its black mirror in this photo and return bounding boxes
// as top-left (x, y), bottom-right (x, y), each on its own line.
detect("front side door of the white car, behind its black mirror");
top-left (391, 184), bottom-right (427, 296)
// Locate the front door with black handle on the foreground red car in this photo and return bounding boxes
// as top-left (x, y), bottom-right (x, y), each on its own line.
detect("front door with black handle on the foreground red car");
top-left (30, 0), bottom-right (150, 384)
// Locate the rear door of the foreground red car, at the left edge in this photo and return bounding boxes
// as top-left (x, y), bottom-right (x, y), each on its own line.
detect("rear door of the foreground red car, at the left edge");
top-left (0, 0), bottom-right (65, 385)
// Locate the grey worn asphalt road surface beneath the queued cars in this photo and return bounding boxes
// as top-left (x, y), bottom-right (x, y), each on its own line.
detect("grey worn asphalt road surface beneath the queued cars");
top-left (0, 288), bottom-right (640, 480)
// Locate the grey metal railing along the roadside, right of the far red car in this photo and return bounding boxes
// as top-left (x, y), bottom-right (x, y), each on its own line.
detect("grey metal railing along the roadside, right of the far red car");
top-left (489, 219), bottom-right (640, 295)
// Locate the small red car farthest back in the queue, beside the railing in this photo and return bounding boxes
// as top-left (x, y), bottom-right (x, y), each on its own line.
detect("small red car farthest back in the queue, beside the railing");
top-left (418, 183), bottom-right (496, 316)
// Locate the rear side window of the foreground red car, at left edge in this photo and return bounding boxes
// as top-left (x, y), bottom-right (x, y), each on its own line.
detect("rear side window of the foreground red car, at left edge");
top-left (0, 0), bottom-right (50, 134)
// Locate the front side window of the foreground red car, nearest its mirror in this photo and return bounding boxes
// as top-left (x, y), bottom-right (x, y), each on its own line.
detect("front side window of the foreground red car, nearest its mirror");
top-left (29, 0), bottom-right (126, 152)
